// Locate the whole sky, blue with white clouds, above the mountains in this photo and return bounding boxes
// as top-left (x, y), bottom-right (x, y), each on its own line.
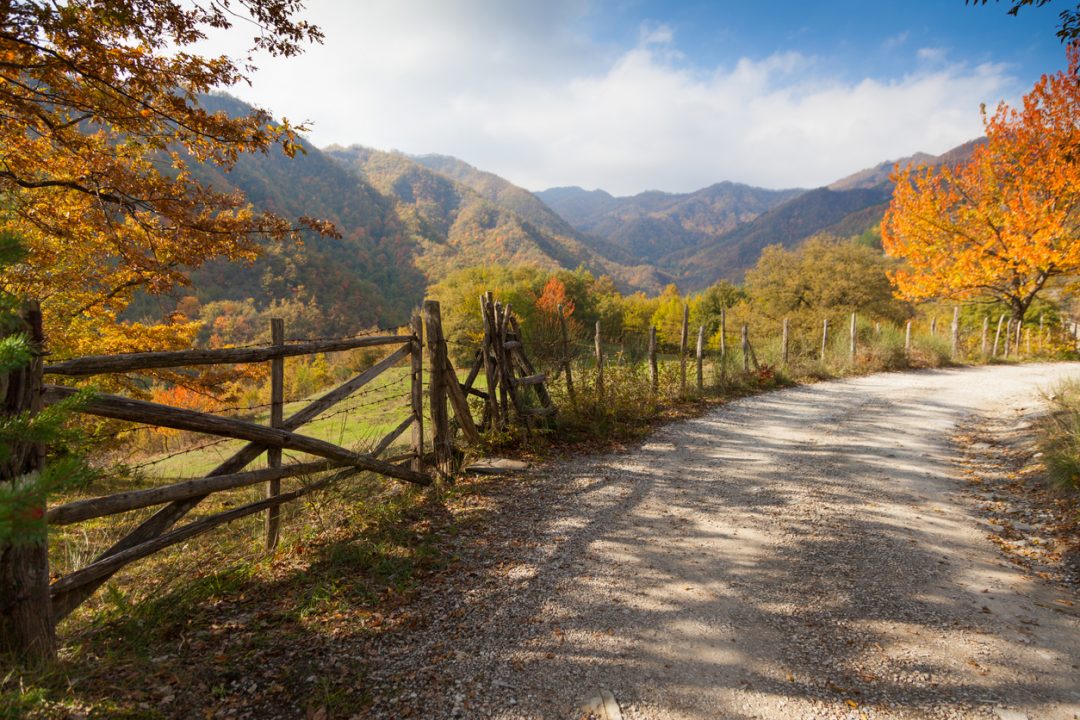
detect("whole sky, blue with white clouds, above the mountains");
top-left (208, 0), bottom-right (1065, 194)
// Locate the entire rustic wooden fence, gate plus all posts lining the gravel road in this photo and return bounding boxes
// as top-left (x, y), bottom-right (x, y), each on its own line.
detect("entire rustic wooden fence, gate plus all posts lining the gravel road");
top-left (0, 293), bottom-right (1080, 656)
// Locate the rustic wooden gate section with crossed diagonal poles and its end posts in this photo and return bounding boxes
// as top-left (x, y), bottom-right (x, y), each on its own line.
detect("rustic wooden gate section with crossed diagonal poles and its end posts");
top-left (0, 301), bottom-right (480, 657)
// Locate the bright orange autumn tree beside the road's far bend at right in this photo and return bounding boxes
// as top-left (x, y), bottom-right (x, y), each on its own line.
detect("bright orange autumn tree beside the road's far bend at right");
top-left (881, 45), bottom-right (1080, 320)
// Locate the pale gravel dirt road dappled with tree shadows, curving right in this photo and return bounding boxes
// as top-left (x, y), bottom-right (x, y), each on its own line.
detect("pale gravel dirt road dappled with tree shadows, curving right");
top-left (365, 364), bottom-right (1080, 720)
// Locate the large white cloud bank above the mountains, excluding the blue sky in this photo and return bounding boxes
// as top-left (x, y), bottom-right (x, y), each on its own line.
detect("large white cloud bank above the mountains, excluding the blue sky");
top-left (204, 0), bottom-right (1012, 193)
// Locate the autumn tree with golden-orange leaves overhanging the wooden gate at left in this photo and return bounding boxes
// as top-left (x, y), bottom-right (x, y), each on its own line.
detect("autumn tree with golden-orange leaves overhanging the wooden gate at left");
top-left (0, 0), bottom-right (330, 354)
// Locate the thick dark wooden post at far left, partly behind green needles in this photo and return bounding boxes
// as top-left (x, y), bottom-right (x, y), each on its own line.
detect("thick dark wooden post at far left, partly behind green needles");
top-left (0, 302), bottom-right (56, 662)
